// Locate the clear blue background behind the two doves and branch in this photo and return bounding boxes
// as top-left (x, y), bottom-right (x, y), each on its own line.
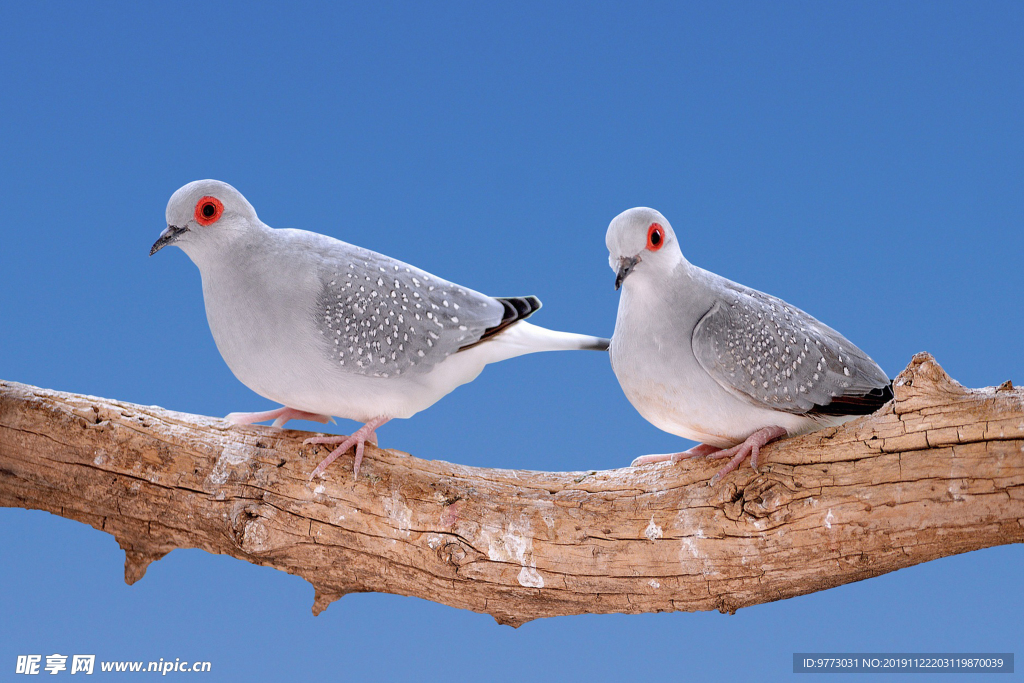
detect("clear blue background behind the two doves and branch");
top-left (0, 2), bottom-right (1024, 681)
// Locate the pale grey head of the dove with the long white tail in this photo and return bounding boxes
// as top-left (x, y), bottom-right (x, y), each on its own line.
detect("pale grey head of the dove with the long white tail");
top-left (150, 180), bottom-right (260, 264)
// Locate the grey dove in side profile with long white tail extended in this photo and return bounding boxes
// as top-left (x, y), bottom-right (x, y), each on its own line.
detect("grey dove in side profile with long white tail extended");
top-left (150, 180), bottom-right (608, 479)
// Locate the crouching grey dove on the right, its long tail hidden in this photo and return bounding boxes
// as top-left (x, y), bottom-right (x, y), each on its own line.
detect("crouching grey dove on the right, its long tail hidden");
top-left (605, 207), bottom-right (893, 484)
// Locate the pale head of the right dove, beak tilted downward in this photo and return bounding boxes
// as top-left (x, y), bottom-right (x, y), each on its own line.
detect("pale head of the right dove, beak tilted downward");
top-left (604, 207), bottom-right (684, 290)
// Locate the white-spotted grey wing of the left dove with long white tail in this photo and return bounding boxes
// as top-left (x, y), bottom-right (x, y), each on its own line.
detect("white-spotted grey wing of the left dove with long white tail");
top-left (315, 243), bottom-right (504, 377)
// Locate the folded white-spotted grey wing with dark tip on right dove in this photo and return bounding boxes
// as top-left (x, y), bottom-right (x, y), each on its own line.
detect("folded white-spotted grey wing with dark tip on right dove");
top-left (692, 286), bottom-right (892, 415)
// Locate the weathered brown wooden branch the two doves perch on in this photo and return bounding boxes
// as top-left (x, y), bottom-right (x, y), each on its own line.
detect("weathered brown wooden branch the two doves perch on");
top-left (0, 354), bottom-right (1024, 625)
